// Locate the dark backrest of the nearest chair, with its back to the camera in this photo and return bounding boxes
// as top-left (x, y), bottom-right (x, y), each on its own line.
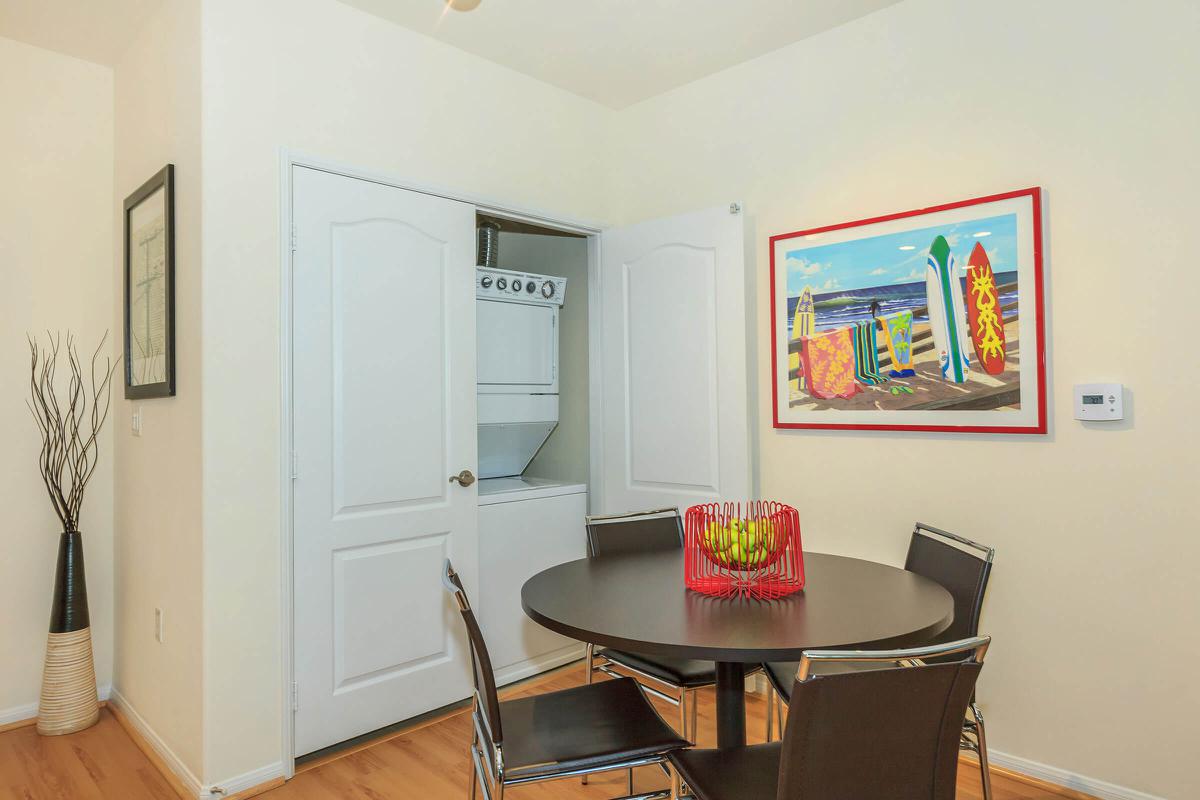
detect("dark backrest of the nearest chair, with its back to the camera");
top-left (776, 637), bottom-right (990, 800)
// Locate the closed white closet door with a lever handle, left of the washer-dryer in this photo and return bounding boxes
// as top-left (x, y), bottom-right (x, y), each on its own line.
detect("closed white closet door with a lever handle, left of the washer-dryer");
top-left (291, 167), bottom-right (478, 754)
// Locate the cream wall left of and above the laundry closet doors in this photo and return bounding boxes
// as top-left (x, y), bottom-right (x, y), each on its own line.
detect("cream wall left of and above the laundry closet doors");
top-left (196, 0), bottom-right (608, 782)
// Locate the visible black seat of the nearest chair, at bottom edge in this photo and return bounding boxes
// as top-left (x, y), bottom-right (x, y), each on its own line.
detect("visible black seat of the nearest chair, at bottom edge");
top-left (671, 741), bottom-right (781, 800)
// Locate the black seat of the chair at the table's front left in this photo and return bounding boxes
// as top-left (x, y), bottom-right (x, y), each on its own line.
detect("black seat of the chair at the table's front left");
top-left (500, 678), bottom-right (688, 776)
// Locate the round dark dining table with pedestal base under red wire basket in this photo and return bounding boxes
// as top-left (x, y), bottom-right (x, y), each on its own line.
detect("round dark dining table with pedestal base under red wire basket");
top-left (521, 549), bottom-right (954, 748)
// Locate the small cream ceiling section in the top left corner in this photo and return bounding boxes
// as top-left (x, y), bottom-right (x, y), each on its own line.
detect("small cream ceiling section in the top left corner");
top-left (0, 0), bottom-right (164, 66)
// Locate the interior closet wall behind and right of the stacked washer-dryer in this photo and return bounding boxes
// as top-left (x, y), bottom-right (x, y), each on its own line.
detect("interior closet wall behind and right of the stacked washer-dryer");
top-left (499, 231), bottom-right (590, 483)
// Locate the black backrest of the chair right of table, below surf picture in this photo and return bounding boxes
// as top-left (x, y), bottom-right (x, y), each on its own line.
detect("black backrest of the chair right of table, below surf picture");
top-left (904, 522), bottom-right (995, 642)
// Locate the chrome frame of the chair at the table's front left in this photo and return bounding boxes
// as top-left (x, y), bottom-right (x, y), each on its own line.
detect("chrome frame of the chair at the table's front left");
top-left (442, 560), bottom-right (672, 800)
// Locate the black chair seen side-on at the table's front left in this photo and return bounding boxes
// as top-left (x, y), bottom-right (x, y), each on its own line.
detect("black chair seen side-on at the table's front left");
top-left (442, 560), bottom-right (688, 800)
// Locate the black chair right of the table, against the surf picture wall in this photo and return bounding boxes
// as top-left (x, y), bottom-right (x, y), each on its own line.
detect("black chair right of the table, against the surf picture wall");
top-left (763, 522), bottom-right (996, 800)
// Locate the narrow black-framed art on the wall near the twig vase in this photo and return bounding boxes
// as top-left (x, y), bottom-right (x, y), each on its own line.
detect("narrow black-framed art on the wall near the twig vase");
top-left (125, 164), bottom-right (175, 399)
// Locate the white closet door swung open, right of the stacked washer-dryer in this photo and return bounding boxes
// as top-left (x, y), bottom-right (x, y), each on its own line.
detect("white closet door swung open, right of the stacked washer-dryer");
top-left (600, 206), bottom-right (750, 513)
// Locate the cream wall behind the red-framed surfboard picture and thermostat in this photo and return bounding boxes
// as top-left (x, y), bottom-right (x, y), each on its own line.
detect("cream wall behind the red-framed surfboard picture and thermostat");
top-left (611, 0), bottom-right (1200, 798)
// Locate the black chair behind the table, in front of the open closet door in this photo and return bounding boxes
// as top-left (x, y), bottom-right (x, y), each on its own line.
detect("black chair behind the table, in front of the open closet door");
top-left (584, 509), bottom-right (748, 741)
